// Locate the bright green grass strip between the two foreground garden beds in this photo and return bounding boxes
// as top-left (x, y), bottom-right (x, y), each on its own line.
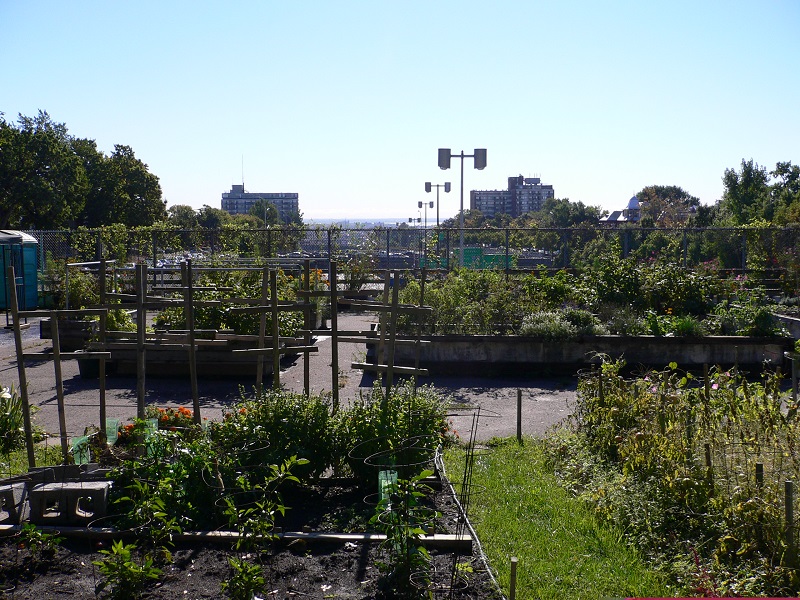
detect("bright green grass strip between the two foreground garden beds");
top-left (445, 438), bottom-right (672, 600)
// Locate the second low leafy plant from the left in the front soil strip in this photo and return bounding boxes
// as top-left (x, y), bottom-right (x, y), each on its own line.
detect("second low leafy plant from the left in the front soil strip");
top-left (92, 540), bottom-right (161, 599)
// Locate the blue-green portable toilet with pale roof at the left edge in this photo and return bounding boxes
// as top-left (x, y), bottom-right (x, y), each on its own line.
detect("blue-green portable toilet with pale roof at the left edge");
top-left (0, 230), bottom-right (39, 310)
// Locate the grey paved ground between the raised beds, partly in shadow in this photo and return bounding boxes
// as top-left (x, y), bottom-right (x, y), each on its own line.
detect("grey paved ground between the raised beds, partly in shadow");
top-left (0, 313), bottom-right (577, 440)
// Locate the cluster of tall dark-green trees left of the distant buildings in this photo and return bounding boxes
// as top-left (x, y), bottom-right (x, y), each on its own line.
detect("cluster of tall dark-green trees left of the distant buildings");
top-left (0, 111), bottom-right (166, 229)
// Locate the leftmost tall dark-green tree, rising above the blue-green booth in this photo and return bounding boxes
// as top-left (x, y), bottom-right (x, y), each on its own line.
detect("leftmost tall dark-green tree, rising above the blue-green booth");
top-left (0, 111), bottom-right (89, 229)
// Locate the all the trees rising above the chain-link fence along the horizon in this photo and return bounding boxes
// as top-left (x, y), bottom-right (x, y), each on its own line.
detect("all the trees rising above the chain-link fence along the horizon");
top-left (0, 111), bottom-right (800, 229)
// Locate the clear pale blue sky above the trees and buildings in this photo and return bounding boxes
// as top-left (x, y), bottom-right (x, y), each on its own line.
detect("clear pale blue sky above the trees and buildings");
top-left (0, 0), bottom-right (800, 221)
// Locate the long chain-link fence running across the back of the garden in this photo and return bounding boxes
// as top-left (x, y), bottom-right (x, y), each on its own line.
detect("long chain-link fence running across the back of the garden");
top-left (27, 226), bottom-right (800, 287)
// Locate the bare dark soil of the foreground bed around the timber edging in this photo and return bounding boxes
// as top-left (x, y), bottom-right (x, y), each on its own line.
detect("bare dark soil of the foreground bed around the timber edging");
top-left (0, 488), bottom-right (497, 600)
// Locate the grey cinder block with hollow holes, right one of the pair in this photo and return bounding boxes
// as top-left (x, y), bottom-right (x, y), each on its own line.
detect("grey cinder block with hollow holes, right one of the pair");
top-left (29, 481), bottom-right (111, 525)
